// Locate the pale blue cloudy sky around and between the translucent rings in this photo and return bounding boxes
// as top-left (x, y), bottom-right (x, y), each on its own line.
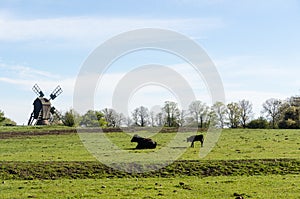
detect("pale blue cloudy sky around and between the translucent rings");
top-left (0, 0), bottom-right (300, 125)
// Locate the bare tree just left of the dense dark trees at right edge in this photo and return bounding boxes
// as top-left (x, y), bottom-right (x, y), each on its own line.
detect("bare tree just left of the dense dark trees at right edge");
top-left (262, 98), bottom-right (282, 129)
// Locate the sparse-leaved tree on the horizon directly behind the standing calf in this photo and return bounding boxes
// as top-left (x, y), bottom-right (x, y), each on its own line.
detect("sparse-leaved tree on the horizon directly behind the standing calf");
top-left (189, 100), bottom-right (209, 128)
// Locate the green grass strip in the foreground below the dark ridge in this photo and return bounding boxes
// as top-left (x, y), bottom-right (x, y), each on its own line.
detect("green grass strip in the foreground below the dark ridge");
top-left (0, 175), bottom-right (300, 199)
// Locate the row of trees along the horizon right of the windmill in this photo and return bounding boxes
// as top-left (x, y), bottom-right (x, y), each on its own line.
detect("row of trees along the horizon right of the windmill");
top-left (63, 97), bottom-right (300, 129)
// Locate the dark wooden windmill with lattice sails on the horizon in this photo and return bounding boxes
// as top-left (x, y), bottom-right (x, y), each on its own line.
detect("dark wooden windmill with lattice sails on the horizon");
top-left (28, 84), bottom-right (62, 125)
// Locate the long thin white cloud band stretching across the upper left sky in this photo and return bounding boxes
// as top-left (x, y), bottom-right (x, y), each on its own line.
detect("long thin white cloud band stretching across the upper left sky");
top-left (0, 15), bottom-right (223, 45)
